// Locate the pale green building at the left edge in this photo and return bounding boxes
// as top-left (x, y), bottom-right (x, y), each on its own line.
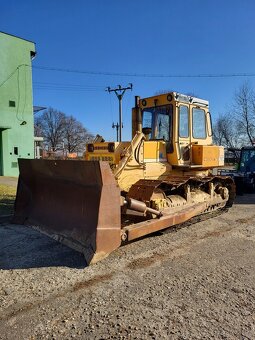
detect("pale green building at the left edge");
top-left (0, 32), bottom-right (35, 176)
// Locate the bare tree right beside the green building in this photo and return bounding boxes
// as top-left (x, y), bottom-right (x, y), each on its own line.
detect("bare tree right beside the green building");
top-left (35, 107), bottom-right (65, 151)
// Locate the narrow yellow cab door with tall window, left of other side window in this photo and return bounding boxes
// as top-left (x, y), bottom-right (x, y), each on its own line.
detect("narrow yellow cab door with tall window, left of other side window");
top-left (177, 104), bottom-right (191, 165)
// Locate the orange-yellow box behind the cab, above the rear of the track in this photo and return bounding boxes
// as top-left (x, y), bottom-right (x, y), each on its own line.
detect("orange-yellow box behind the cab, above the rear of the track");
top-left (192, 145), bottom-right (224, 167)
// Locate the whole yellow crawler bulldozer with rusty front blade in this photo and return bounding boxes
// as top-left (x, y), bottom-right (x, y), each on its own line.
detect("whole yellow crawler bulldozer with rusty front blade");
top-left (14, 92), bottom-right (235, 264)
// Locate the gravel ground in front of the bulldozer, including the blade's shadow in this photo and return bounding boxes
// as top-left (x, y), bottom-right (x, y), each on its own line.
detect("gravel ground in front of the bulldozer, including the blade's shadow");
top-left (0, 195), bottom-right (255, 339)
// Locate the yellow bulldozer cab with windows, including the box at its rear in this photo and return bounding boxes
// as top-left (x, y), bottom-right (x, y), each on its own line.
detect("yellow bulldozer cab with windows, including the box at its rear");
top-left (132, 92), bottom-right (224, 168)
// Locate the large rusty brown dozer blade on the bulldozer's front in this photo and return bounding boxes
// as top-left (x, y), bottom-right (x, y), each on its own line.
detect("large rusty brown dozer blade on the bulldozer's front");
top-left (13, 159), bottom-right (121, 264)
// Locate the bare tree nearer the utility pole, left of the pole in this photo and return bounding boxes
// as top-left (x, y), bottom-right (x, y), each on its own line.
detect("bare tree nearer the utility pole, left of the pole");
top-left (63, 116), bottom-right (93, 152)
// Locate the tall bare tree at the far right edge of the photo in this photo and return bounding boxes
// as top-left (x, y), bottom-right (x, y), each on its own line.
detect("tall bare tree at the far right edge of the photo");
top-left (233, 82), bottom-right (255, 145)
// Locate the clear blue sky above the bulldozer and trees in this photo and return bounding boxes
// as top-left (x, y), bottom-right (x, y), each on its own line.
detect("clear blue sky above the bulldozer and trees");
top-left (0, 0), bottom-right (255, 140)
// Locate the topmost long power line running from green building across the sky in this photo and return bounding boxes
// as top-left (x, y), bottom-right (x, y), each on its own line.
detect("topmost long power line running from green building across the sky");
top-left (32, 65), bottom-right (255, 78)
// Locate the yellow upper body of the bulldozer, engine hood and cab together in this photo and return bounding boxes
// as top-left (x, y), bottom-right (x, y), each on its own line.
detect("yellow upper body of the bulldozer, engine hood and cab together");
top-left (85, 92), bottom-right (224, 171)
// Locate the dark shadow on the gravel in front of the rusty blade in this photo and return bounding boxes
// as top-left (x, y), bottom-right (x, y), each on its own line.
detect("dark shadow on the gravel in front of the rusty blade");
top-left (0, 224), bottom-right (86, 269)
